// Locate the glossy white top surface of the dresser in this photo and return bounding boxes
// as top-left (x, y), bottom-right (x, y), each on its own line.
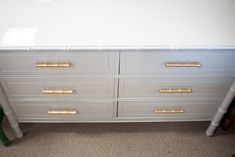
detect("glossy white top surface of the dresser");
top-left (0, 0), bottom-right (235, 49)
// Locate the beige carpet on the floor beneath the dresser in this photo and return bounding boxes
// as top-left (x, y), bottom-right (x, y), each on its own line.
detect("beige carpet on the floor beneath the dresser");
top-left (0, 120), bottom-right (235, 157)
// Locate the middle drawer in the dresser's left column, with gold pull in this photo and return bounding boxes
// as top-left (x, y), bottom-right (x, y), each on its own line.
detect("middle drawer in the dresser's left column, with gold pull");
top-left (0, 77), bottom-right (114, 100)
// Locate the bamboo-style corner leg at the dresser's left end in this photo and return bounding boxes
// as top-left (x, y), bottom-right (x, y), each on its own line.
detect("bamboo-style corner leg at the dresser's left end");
top-left (0, 86), bottom-right (23, 138)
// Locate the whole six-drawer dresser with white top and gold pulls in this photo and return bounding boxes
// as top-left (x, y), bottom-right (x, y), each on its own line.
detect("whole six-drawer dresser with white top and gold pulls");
top-left (0, 0), bottom-right (235, 137)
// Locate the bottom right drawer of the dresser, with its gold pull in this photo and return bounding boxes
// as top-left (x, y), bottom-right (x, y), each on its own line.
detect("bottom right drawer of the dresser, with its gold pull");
top-left (118, 100), bottom-right (221, 121)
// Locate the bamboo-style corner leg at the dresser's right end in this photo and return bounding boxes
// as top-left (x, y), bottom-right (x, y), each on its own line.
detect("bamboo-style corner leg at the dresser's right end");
top-left (206, 81), bottom-right (235, 136)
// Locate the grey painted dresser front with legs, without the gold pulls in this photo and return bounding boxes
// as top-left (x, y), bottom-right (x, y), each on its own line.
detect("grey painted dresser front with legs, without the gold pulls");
top-left (0, 49), bottom-right (235, 137)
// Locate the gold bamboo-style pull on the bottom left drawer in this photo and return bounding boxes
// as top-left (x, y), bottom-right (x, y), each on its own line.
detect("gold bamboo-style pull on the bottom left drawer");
top-left (48, 108), bottom-right (78, 115)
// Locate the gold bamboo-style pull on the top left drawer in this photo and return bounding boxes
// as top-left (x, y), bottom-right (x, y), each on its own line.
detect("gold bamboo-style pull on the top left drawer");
top-left (34, 62), bottom-right (72, 68)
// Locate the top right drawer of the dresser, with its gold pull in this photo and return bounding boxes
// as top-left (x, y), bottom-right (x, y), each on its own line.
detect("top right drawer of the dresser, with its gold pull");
top-left (120, 50), bottom-right (235, 77)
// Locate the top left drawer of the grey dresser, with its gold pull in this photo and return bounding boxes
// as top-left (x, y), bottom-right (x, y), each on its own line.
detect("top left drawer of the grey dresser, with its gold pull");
top-left (0, 51), bottom-right (118, 75)
